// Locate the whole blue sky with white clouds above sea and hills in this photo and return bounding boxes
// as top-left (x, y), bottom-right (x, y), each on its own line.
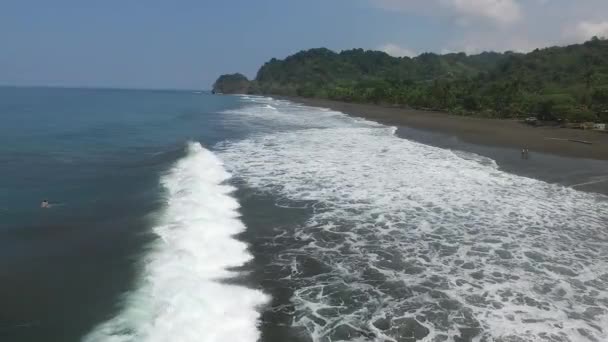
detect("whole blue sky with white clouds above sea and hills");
top-left (0, 0), bottom-right (608, 89)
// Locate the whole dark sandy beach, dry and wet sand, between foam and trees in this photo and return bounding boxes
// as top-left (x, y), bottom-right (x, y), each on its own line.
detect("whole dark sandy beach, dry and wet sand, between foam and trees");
top-left (284, 98), bottom-right (608, 195)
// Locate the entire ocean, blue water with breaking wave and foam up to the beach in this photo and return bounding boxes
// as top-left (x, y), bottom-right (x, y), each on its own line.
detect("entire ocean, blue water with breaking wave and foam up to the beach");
top-left (0, 87), bottom-right (608, 342)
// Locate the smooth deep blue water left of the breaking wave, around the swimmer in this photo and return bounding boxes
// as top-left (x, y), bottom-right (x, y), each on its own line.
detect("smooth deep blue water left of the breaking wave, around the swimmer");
top-left (0, 88), bottom-right (247, 341)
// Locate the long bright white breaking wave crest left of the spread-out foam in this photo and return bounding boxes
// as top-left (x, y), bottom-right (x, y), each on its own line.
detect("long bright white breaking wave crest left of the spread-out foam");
top-left (84, 143), bottom-right (267, 342)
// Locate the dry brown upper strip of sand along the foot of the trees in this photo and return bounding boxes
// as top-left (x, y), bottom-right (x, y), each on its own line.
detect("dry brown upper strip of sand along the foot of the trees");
top-left (275, 96), bottom-right (608, 160)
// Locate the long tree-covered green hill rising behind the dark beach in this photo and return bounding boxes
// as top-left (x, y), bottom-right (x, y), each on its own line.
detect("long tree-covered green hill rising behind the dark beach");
top-left (213, 37), bottom-right (608, 122)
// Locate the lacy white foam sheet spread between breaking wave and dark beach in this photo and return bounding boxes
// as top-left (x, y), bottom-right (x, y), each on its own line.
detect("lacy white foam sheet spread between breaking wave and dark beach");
top-left (218, 100), bottom-right (608, 341)
